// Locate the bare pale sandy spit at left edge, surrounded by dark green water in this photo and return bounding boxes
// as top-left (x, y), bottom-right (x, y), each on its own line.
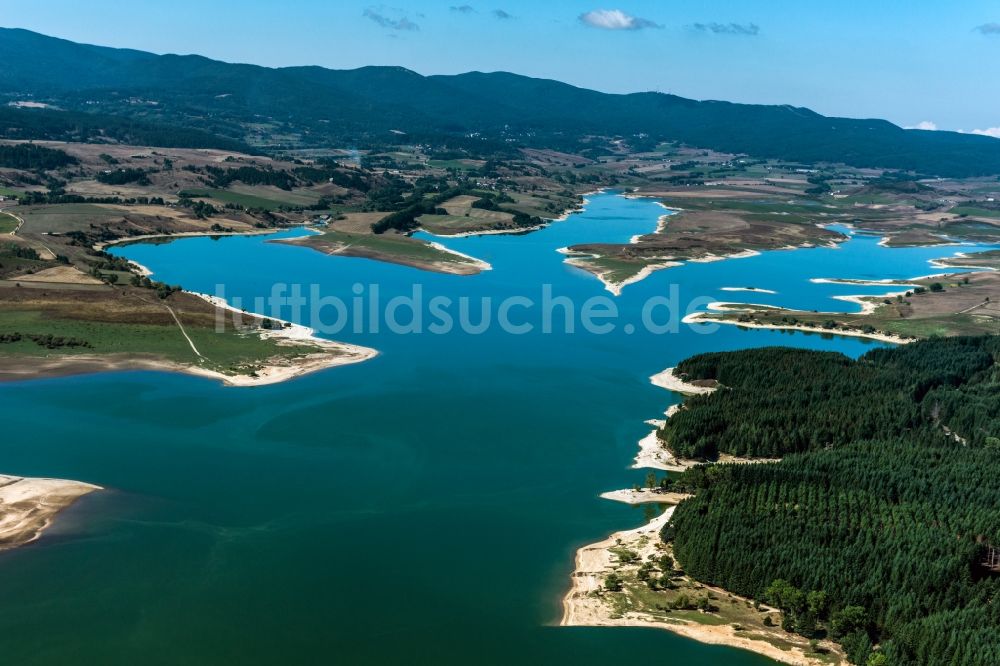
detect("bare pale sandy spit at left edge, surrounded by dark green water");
top-left (0, 475), bottom-right (103, 551)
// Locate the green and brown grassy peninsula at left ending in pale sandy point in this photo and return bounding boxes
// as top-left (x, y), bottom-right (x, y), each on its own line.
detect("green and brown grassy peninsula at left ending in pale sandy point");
top-left (0, 231), bottom-right (377, 387)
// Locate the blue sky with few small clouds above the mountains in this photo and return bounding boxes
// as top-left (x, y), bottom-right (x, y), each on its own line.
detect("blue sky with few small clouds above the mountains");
top-left (0, 0), bottom-right (1000, 134)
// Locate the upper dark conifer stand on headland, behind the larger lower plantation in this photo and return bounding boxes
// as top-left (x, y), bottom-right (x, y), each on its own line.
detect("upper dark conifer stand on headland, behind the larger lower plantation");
top-left (660, 338), bottom-right (1000, 459)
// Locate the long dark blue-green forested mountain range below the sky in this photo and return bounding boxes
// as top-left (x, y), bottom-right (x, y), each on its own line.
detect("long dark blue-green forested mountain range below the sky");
top-left (0, 29), bottom-right (1000, 177)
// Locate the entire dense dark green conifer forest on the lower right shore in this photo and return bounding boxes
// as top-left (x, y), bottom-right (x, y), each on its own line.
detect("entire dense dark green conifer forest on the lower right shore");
top-left (664, 337), bottom-right (1000, 665)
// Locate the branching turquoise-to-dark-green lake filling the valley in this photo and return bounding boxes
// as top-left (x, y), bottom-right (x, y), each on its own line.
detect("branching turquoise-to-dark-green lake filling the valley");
top-left (0, 194), bottom-right (996, 665)
